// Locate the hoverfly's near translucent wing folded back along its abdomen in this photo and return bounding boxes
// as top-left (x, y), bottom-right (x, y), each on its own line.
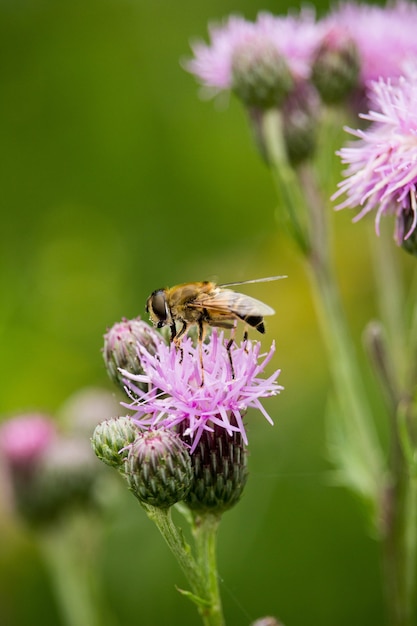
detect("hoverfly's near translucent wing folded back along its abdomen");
top-left (189, 289), bottom-right (275, 317)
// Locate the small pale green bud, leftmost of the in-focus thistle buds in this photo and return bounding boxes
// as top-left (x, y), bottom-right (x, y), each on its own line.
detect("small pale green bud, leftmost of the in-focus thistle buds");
top-left (91, 417), bottom-right (139, 470)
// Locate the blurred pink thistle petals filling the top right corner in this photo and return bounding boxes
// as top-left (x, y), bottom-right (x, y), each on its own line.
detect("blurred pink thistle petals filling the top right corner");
top-left (323, 0), bottom-right (417, 87)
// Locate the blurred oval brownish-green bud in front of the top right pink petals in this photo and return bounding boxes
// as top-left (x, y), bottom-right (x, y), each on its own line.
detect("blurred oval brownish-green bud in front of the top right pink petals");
top-left (311, 27), bottom-right (360, 104)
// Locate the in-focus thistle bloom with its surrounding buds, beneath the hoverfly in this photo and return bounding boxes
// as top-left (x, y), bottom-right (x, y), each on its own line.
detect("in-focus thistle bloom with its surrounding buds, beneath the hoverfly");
top-left (92, 319), bottom-right (282, 513)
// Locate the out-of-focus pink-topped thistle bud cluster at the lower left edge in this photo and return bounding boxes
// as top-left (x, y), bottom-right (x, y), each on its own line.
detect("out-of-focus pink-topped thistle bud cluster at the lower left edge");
top-left (0, 398), bottom-right (112, 526)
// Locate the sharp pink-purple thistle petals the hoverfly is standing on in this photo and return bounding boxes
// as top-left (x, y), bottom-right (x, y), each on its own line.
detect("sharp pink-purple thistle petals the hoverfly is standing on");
top-left (122, 330), bottom-right (283, 453)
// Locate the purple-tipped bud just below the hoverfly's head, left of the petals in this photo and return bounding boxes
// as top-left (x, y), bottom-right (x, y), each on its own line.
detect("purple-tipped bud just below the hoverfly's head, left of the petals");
top-left (103, 317), bottom-right (162, 391)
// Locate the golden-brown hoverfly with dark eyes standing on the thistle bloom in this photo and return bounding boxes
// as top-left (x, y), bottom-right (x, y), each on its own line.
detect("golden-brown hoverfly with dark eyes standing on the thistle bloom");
top-left (146, 276), bottom-right (286, 384)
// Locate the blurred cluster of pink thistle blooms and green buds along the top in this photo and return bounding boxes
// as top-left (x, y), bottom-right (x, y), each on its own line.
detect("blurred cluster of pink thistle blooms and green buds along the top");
top-left (187, 0), bottom-right (417, 165)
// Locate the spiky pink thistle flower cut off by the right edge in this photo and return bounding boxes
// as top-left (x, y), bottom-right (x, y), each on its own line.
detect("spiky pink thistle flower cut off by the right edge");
top-left (332, 68), bottom-right (417, 245)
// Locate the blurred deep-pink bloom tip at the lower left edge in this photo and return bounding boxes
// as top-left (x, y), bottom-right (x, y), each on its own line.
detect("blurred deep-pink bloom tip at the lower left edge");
top-left (0, 413), bottom-right (56, 467)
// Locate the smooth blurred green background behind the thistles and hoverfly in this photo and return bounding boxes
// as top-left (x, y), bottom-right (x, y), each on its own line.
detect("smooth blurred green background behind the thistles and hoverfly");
top-left (0, 0), bottom-right (407, 626)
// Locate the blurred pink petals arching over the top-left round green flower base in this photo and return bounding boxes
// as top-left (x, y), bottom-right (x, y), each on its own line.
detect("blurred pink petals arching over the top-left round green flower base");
top-left (187, 10), bottom-right (320, 93)
